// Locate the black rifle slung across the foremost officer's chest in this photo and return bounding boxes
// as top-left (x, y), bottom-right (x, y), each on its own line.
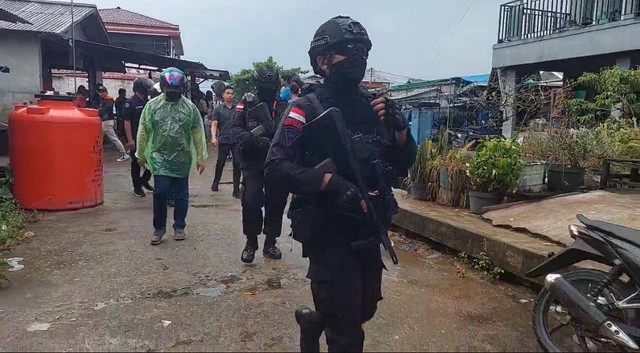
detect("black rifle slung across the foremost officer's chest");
top-left (305, 108), bottom-right (398, 265)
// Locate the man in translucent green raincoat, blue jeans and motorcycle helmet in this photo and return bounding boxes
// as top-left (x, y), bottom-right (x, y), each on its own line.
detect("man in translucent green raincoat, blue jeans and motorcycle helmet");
top-left (136, 67), bottom-right (207, 245)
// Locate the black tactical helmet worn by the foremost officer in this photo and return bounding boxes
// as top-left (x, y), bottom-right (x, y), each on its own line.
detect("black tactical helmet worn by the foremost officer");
top-left (309, 16), bottom-right (371, 75)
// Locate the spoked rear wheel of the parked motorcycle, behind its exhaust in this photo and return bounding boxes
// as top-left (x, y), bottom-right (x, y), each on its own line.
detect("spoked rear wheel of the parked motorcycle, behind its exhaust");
top-left (533, 270), bottom-right (634, 352)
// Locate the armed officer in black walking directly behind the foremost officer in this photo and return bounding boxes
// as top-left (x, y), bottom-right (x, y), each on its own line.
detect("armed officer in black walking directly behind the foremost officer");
top-left (231, 66), bottom-right (288, 263)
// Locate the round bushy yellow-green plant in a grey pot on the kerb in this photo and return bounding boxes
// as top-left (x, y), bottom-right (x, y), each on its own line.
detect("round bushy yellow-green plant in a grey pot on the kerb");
top-left (467, 139), bottom-right (523, 214)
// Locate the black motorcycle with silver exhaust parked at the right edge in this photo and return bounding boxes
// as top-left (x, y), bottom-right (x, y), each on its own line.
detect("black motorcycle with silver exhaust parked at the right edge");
top-left (526, 215), bottom-right (640, 352)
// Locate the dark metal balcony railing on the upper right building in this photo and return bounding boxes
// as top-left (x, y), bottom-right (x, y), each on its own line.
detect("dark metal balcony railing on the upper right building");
top-left (498, 0), bottom-right (640, 43)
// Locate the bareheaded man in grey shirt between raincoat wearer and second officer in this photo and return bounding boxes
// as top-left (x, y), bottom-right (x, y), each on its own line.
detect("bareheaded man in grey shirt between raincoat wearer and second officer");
top-left (211, 86), bottom-right (240, 199)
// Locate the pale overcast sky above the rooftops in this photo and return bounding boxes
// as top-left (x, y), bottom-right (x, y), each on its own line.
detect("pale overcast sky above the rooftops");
top-left (86, 0), bottom-right (506, 79)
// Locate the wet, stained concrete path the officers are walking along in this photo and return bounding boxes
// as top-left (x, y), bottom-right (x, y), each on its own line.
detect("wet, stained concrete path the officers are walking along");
top-left (0, 147), bottom-right (538, 351)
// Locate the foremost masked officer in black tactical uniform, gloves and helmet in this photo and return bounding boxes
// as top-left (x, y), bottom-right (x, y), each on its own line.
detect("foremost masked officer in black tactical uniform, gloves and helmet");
top-left (265, 16), bottom-right (416, 352)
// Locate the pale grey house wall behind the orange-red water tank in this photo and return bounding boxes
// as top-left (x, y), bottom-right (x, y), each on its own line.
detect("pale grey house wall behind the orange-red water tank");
top-left (0, 31), bottom-right (42, 122)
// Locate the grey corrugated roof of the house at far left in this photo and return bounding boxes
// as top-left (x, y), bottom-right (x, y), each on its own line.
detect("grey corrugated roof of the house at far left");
top-left (0, 0), bottom-right (97, 34)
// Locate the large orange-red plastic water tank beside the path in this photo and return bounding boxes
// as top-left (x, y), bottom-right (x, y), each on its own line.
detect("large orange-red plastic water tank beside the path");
top-left (9, 95), bottom-right (104, 210)
